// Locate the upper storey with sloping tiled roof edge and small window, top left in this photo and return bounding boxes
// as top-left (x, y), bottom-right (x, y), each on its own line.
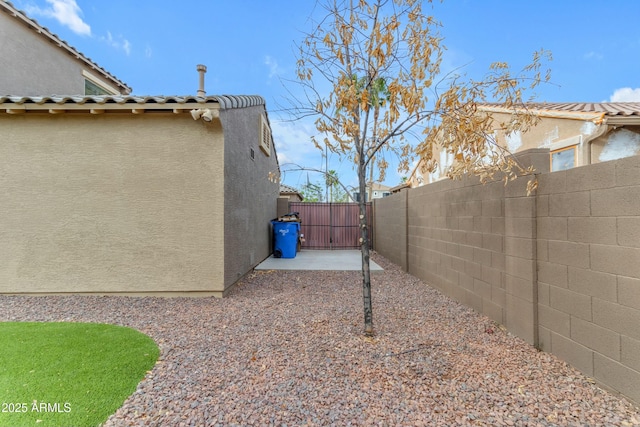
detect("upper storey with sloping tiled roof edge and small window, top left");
top-left (0, 0), bottom-right (131, 96)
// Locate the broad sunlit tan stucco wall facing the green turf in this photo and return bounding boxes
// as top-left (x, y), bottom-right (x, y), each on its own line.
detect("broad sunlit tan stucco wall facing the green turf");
top-left (0, 113), bottom-right (224, 293)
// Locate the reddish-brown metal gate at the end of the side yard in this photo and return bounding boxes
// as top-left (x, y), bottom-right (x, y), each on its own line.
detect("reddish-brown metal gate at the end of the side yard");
top-left (289, 202), bottom-right (373, 249)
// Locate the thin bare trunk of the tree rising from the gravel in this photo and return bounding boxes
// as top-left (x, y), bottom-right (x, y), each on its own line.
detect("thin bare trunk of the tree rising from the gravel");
top-left (358, 156), bottom-right (373, 336)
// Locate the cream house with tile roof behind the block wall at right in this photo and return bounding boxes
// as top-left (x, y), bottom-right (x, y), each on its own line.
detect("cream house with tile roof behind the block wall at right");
top-left (409, 102), bottom-right (640, 187)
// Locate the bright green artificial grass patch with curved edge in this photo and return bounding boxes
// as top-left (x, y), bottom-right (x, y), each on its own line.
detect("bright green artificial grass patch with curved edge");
top-left (0, 322), bottom-right (160, 427)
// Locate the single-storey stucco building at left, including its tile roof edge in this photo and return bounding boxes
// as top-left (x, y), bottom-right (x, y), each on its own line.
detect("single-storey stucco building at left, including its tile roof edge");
top-left (0, 96), bottom-right (279, 296)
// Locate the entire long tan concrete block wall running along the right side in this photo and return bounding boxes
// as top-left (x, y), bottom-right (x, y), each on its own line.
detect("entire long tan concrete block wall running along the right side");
top-left (375, 149), bottom-right (640, 402)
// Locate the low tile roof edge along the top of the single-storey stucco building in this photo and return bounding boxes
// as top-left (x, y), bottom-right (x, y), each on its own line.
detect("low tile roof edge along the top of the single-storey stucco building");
top-left (0, 95), bottom-right (266, 109)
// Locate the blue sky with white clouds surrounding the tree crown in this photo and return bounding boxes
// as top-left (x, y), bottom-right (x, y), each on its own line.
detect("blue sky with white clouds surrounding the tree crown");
top-left (12, 0), bottom-right (640, 191)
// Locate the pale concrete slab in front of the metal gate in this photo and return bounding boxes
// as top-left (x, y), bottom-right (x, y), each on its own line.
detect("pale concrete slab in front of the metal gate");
top-left (255, 249), bottom-right (383, 273)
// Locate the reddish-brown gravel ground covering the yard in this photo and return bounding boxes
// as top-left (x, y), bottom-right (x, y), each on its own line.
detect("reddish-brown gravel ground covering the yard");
top-left (0, 255), bottom-right (640, 426)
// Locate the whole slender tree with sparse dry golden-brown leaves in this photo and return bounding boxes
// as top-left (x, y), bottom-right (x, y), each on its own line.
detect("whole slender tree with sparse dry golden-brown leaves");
top-left (294, 0), bottom-right (548, 335)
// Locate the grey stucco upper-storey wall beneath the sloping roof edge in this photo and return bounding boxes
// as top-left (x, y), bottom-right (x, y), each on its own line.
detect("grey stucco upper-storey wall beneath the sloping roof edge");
top-left (0, 12), bottom-right (113, 96)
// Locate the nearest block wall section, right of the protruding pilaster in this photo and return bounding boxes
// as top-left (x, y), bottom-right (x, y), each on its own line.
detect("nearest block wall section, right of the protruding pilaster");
top-left (536, 156), bottom-right (640, 402)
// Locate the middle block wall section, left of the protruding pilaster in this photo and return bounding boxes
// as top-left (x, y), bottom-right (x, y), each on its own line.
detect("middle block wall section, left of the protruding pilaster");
top-left (410, 180), bottom-right (506, 323)
